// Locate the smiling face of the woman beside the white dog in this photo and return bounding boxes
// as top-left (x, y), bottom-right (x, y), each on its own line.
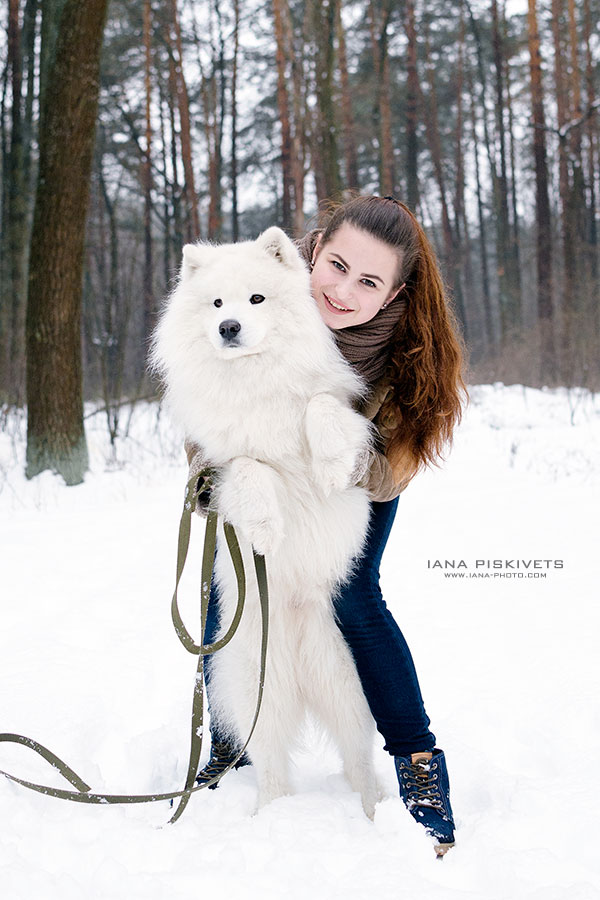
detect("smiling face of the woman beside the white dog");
top-left (310, 222), bottom-right (401, 328)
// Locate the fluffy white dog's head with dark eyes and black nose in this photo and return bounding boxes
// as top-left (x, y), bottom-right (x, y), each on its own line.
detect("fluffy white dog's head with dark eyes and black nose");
top-left (168, 227), bottom-right (316, 359)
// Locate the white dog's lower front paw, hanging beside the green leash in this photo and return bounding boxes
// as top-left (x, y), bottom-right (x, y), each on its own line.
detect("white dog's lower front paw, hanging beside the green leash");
top-left (218, 456), bottom-right (284, 556)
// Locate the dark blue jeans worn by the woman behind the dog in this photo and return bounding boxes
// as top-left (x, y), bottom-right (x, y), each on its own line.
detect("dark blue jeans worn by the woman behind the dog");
top-left (205, 498), bottom-right (435, 756)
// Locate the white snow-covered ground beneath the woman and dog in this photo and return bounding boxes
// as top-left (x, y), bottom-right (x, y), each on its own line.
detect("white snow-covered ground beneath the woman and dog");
top-left (0, 385), bottom-right (600, 900)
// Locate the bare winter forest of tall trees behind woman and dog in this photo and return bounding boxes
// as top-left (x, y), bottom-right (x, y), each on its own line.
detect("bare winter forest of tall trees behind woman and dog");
top-left (0, 0), bottom-right (600, 486)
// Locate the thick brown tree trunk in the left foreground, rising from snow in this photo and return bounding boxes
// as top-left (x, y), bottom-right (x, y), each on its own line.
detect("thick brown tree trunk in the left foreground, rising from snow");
top-left (26, 0), bottom-right (108, 484)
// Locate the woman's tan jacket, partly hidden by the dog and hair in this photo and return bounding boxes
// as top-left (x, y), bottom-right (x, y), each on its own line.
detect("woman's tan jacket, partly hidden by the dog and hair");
top-left (185, 381), bottom-right (406, 512)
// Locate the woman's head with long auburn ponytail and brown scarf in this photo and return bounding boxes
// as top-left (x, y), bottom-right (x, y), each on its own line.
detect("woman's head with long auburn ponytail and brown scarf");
top-left (299, 196), bottom-right (466, 492)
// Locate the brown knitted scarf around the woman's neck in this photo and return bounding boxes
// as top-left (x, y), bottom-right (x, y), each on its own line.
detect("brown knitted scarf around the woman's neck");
top-left (296, 229), bottom-right (406, 387)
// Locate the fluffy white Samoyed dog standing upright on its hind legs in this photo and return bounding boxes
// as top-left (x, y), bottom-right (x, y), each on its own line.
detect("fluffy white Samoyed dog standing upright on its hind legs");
top-left (151, 227), bottom-right (377, 817)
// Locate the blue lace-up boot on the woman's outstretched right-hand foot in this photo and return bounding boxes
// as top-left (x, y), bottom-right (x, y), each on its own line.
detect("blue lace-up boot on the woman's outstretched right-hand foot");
top-left (394, 749), bottom-right (454, 857)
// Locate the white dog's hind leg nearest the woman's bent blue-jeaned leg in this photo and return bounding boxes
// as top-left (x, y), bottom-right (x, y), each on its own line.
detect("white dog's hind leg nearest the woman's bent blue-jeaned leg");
top-left (303, 605), bottom-right (380, 819)
